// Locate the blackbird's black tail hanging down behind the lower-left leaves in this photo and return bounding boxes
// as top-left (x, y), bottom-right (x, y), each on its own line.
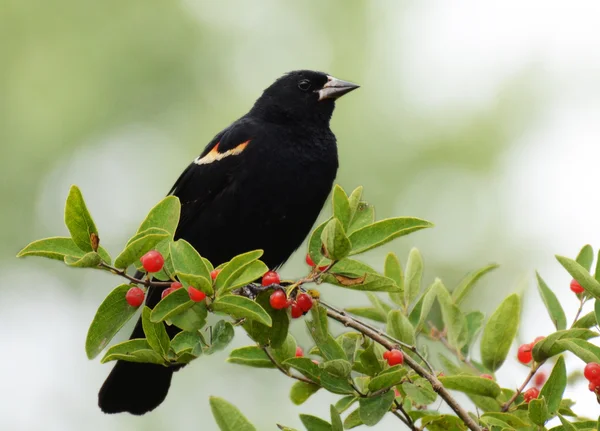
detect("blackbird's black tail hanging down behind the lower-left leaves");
top-left (98, 287), bottom-right (180, 415)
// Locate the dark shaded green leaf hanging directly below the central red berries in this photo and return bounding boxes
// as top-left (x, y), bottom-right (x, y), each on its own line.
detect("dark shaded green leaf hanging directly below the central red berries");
top-left (243, 290), bottom-right (290, 347)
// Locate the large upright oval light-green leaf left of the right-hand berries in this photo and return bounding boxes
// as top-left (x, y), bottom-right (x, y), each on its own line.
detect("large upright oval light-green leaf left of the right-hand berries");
top-left (481, 294), bottom-right (520, 371)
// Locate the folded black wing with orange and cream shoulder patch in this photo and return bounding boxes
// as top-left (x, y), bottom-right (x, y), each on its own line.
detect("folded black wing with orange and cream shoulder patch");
top-left (169, 120), bottom-right (256, 237)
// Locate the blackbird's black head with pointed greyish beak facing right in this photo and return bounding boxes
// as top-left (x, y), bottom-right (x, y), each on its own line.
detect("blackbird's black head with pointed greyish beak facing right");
top-left (252, 70), bottom-right (358, 123)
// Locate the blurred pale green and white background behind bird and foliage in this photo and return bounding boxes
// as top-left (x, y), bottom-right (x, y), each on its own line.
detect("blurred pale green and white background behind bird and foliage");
top-left (0, 0), bottom-right (600, 430)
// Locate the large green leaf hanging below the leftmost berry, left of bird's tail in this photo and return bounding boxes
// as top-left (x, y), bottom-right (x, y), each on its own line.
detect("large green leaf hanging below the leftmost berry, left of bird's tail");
top-left (85, 284), bottom-right (137, 359)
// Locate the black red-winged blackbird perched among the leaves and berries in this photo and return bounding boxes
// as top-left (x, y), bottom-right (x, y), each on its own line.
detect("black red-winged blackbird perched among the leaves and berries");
top-left (98, 70), bottom-right (358, 415)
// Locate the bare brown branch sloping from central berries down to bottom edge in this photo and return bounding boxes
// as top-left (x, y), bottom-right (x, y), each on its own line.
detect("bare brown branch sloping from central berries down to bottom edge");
top-left (321, 302), bottom-right (481, 431)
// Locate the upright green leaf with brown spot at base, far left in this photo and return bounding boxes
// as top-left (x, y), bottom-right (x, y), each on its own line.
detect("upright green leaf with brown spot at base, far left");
top-left (65, 186), bottom-right (98, 252)
